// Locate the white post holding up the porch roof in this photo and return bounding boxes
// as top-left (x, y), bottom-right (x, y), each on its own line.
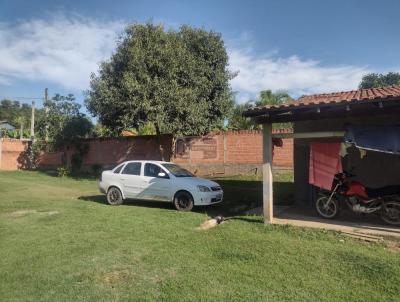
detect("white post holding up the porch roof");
top-left (263, 124), bottom-right (274, 224)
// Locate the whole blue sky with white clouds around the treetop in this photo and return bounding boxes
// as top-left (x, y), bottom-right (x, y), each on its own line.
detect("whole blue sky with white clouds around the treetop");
top-left (0, 0), bottom-right (400, 111)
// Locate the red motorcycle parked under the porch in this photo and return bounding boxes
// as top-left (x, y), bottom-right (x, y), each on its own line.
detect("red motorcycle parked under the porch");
top-left (315, 172), bottom-right (400, 225)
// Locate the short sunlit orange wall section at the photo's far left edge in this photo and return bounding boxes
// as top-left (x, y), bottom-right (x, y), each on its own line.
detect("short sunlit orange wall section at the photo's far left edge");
top-left (0, 138), bottom-right (29, 170)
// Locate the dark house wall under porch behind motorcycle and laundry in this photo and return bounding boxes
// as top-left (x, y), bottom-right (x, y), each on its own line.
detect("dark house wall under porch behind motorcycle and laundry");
top-left (293, 115), bottom-right (400, 207)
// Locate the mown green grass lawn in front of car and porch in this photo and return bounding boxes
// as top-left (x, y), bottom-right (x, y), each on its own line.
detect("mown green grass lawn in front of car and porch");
top-left (0, 172), bottom-right (400, 302)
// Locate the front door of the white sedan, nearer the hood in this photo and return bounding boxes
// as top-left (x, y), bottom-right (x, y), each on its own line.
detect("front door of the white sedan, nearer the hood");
top-left (140, 163), bottom-right (172, 201)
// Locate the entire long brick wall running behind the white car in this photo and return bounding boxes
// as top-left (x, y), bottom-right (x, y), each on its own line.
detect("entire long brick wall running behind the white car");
top-left (0, 130), bottom-right (293, 175)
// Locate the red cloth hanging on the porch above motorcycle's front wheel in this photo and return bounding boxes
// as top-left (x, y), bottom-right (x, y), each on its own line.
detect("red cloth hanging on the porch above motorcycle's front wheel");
top-left (309, 143), bottom-right (343, 190)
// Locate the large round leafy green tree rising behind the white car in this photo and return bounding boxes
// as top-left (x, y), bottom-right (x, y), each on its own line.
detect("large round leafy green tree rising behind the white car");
top-left (86, 24), bottom-right (233, 140)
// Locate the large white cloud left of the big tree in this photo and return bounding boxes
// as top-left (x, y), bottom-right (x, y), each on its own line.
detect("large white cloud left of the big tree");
top-left (0, 15), bottom-right (124, 90)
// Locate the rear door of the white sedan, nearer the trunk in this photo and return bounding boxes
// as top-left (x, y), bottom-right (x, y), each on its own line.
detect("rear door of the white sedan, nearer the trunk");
top-left (120, 162), bottom-right (142, 198)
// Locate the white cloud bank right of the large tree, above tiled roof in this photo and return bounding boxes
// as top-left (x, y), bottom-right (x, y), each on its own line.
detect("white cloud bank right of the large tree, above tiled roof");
top-left (228, 48), bottom-right (370, 102)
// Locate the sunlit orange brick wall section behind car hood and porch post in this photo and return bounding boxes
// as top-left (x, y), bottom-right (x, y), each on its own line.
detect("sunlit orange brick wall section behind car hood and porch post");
top-left (173, 130), bottom-right (293, 174)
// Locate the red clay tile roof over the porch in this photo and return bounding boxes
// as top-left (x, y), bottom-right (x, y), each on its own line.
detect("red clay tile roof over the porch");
top-left (246, 86), bottom-right (400, 113)
